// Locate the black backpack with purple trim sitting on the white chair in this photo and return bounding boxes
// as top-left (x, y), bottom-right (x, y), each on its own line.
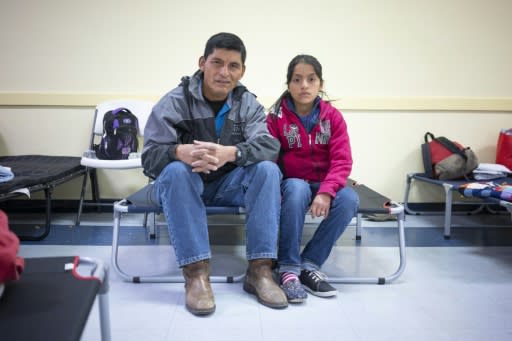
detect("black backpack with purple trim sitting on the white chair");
top-left (94, 108), bottom-right (139, 160)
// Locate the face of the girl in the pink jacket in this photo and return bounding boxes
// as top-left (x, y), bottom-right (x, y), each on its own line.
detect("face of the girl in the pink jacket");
top-left (288, 63), bottom-right (322, 107)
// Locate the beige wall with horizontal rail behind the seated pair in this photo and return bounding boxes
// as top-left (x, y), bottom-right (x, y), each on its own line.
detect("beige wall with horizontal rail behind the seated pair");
top-left (0, 0), bottom-right (512, 201)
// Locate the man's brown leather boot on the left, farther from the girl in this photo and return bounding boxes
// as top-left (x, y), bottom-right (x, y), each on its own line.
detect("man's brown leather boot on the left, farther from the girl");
top-left (183, 260), bottom-right (215, 315)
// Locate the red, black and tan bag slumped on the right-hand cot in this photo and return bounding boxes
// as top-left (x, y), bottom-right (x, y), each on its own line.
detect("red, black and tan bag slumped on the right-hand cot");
top-left (421, 132), bottom-right (478, 180)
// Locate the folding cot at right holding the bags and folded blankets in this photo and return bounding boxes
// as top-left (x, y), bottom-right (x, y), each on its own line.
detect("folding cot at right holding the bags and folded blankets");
top-left (403, 173), bottom-right (512, 239)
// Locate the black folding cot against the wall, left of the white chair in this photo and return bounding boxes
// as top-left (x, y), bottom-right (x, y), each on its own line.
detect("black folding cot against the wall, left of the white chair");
top-left (0, 155), bottom-right (85, 240)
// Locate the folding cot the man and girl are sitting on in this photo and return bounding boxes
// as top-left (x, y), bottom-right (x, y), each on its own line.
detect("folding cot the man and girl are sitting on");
top-left (112, 181), bottom-right (406, 284)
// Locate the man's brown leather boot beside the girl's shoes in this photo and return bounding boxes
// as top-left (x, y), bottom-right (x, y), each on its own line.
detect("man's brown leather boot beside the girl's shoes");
top-left (244, 259), bottom-right (288, 309)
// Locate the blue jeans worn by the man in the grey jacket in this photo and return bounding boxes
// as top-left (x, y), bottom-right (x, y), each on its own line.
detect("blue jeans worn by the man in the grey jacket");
top-left (155, 161), bottom-right (281, 267)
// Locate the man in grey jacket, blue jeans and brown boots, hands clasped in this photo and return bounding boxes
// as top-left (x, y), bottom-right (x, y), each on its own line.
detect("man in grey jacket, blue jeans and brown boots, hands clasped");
top-left (142, 33), bottom-right (288, 315)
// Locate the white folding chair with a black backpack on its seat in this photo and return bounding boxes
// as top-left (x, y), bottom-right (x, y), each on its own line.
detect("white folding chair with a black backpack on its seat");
top-left (76, 99), bottom-right (154, 225)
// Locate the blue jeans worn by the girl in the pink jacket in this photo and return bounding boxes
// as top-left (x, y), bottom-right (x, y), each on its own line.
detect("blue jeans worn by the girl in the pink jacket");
top-left (278, 178), bottom-right (359, 275)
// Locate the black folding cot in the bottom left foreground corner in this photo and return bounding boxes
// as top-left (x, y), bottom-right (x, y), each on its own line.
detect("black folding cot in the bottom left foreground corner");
top-left (0, 256), bottom-right (110, 341)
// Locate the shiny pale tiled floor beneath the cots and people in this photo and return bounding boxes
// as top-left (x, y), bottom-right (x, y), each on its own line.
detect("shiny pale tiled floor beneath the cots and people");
top-left (11, 211), bottom-right (512, 341)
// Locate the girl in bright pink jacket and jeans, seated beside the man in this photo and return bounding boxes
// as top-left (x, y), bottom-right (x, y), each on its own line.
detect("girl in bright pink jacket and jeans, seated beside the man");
top-left (267, 55), bottom-right (359, 303)
